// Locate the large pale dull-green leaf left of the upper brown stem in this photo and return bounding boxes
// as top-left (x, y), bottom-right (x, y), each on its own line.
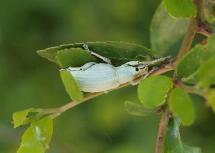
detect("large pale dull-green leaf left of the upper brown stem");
top-left (150, 3), bottom-right (189, 56)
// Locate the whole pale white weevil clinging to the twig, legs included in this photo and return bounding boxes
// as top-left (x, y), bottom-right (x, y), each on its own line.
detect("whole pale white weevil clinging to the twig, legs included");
top-left (61, 44), bottom-right (169, 93)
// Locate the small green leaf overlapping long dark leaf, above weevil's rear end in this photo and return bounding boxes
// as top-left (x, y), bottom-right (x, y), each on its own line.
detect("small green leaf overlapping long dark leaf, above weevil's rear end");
top-left (56, 48), bottom-right (98, 68)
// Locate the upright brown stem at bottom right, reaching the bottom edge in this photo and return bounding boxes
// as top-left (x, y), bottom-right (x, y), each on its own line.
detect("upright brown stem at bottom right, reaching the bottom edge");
top-left (155, 107), bottom-right (169, 153)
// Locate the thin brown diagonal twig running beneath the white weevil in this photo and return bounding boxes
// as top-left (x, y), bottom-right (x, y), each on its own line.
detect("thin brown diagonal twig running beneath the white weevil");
top-left (47, 63), bottom-right (174, 118)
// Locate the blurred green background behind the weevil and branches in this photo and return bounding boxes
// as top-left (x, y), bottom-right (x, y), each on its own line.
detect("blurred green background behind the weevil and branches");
top-left (0, 0), bottom-right (215, 153)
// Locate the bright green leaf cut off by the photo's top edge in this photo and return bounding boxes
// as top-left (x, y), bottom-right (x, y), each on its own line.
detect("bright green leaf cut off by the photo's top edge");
top-left (164, 0), bottom-right (197, 17)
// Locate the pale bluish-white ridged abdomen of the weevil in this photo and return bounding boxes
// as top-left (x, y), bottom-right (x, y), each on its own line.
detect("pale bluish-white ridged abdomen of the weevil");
top-left (68, 63), bottom-right (120, 92)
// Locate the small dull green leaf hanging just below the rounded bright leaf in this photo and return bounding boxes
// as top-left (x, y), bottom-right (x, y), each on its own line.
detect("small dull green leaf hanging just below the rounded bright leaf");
top-left (125, 101), bottom-right (156, 116)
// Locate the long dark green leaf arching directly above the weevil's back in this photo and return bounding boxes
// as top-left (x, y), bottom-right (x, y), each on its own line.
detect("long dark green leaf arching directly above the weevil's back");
top-left (37, 42), bottom-right (154, 67)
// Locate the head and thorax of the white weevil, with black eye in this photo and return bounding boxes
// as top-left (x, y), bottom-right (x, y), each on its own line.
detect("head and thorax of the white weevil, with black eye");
top-left (116, 61), bottom-right (147, 84)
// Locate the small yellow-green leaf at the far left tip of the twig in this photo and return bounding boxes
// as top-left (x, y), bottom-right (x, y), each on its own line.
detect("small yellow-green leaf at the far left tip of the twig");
top-left (12, 108), bottom-right (33, 128)
